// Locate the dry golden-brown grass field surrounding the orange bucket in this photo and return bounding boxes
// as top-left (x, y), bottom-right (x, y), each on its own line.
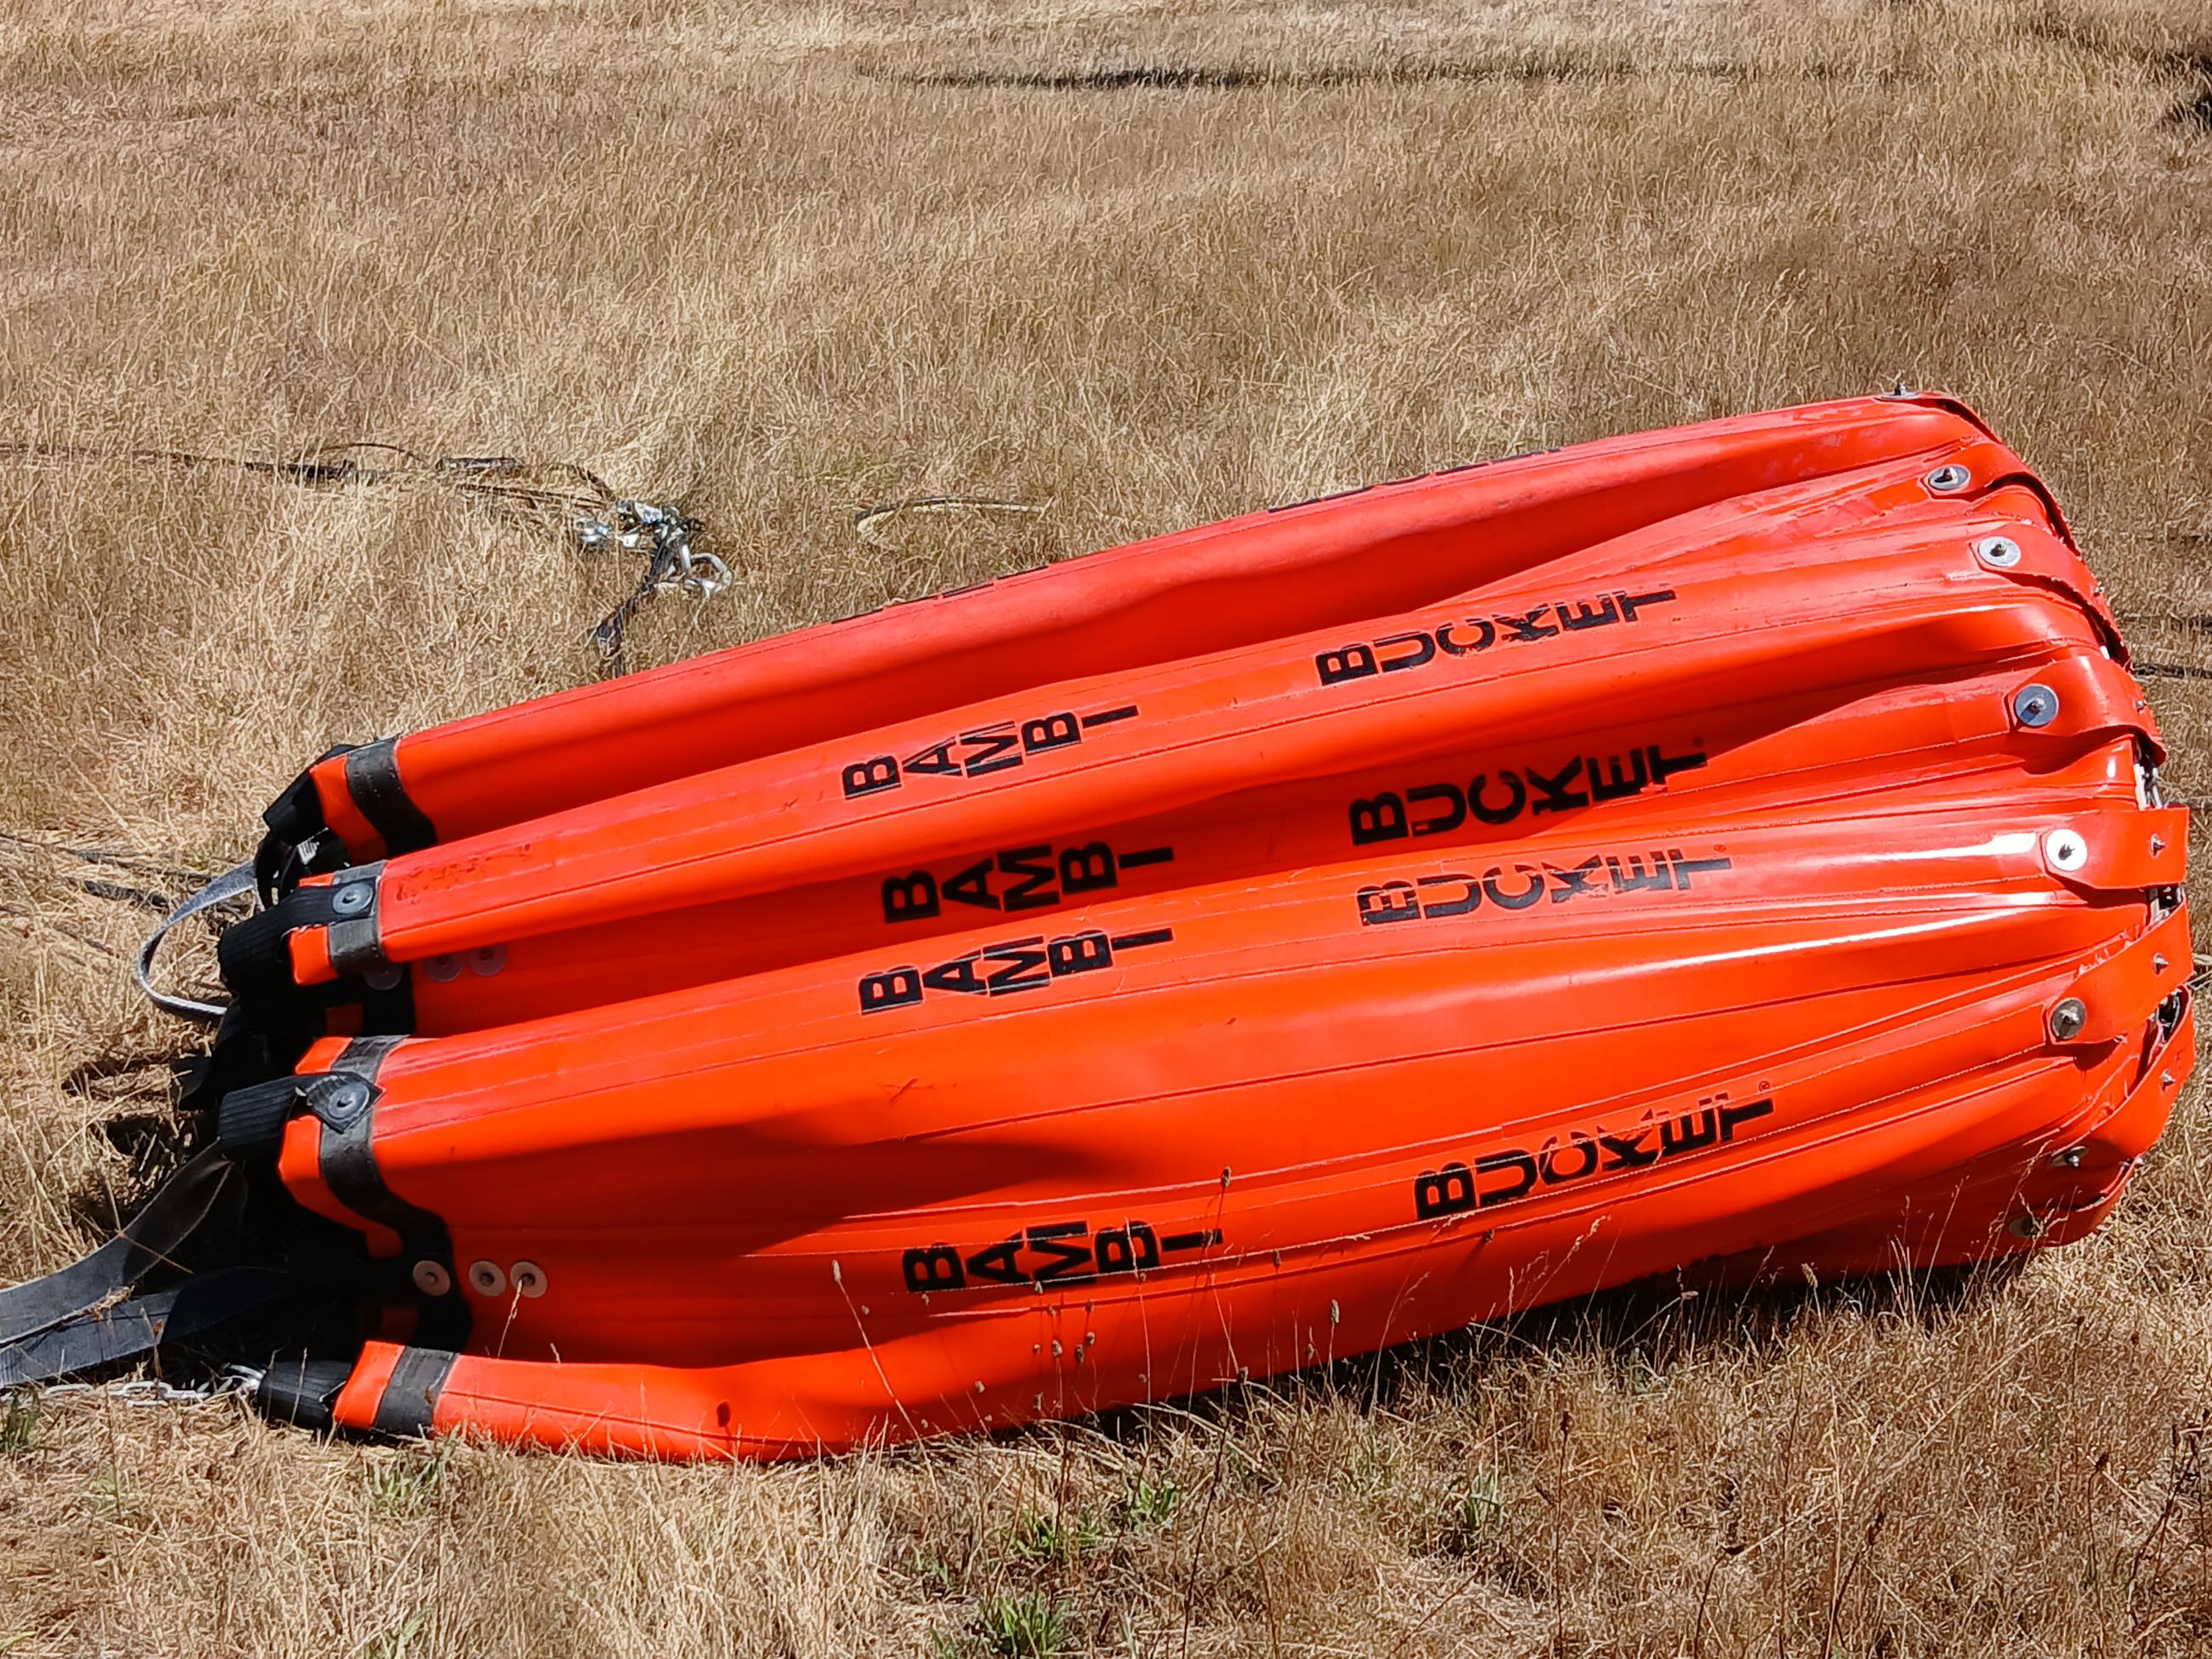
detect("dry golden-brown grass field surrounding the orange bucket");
top-left (0, 0), bottom-right (2212, 1659)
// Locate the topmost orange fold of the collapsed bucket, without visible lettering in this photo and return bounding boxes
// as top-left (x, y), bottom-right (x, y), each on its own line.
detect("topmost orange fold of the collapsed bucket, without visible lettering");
top-left (314, 398), bottom-right (1991, 863)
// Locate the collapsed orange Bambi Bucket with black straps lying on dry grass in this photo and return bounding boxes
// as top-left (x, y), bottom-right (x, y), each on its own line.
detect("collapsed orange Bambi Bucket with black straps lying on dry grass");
top-left (0, 398), bottom-right (2192, 1457)
